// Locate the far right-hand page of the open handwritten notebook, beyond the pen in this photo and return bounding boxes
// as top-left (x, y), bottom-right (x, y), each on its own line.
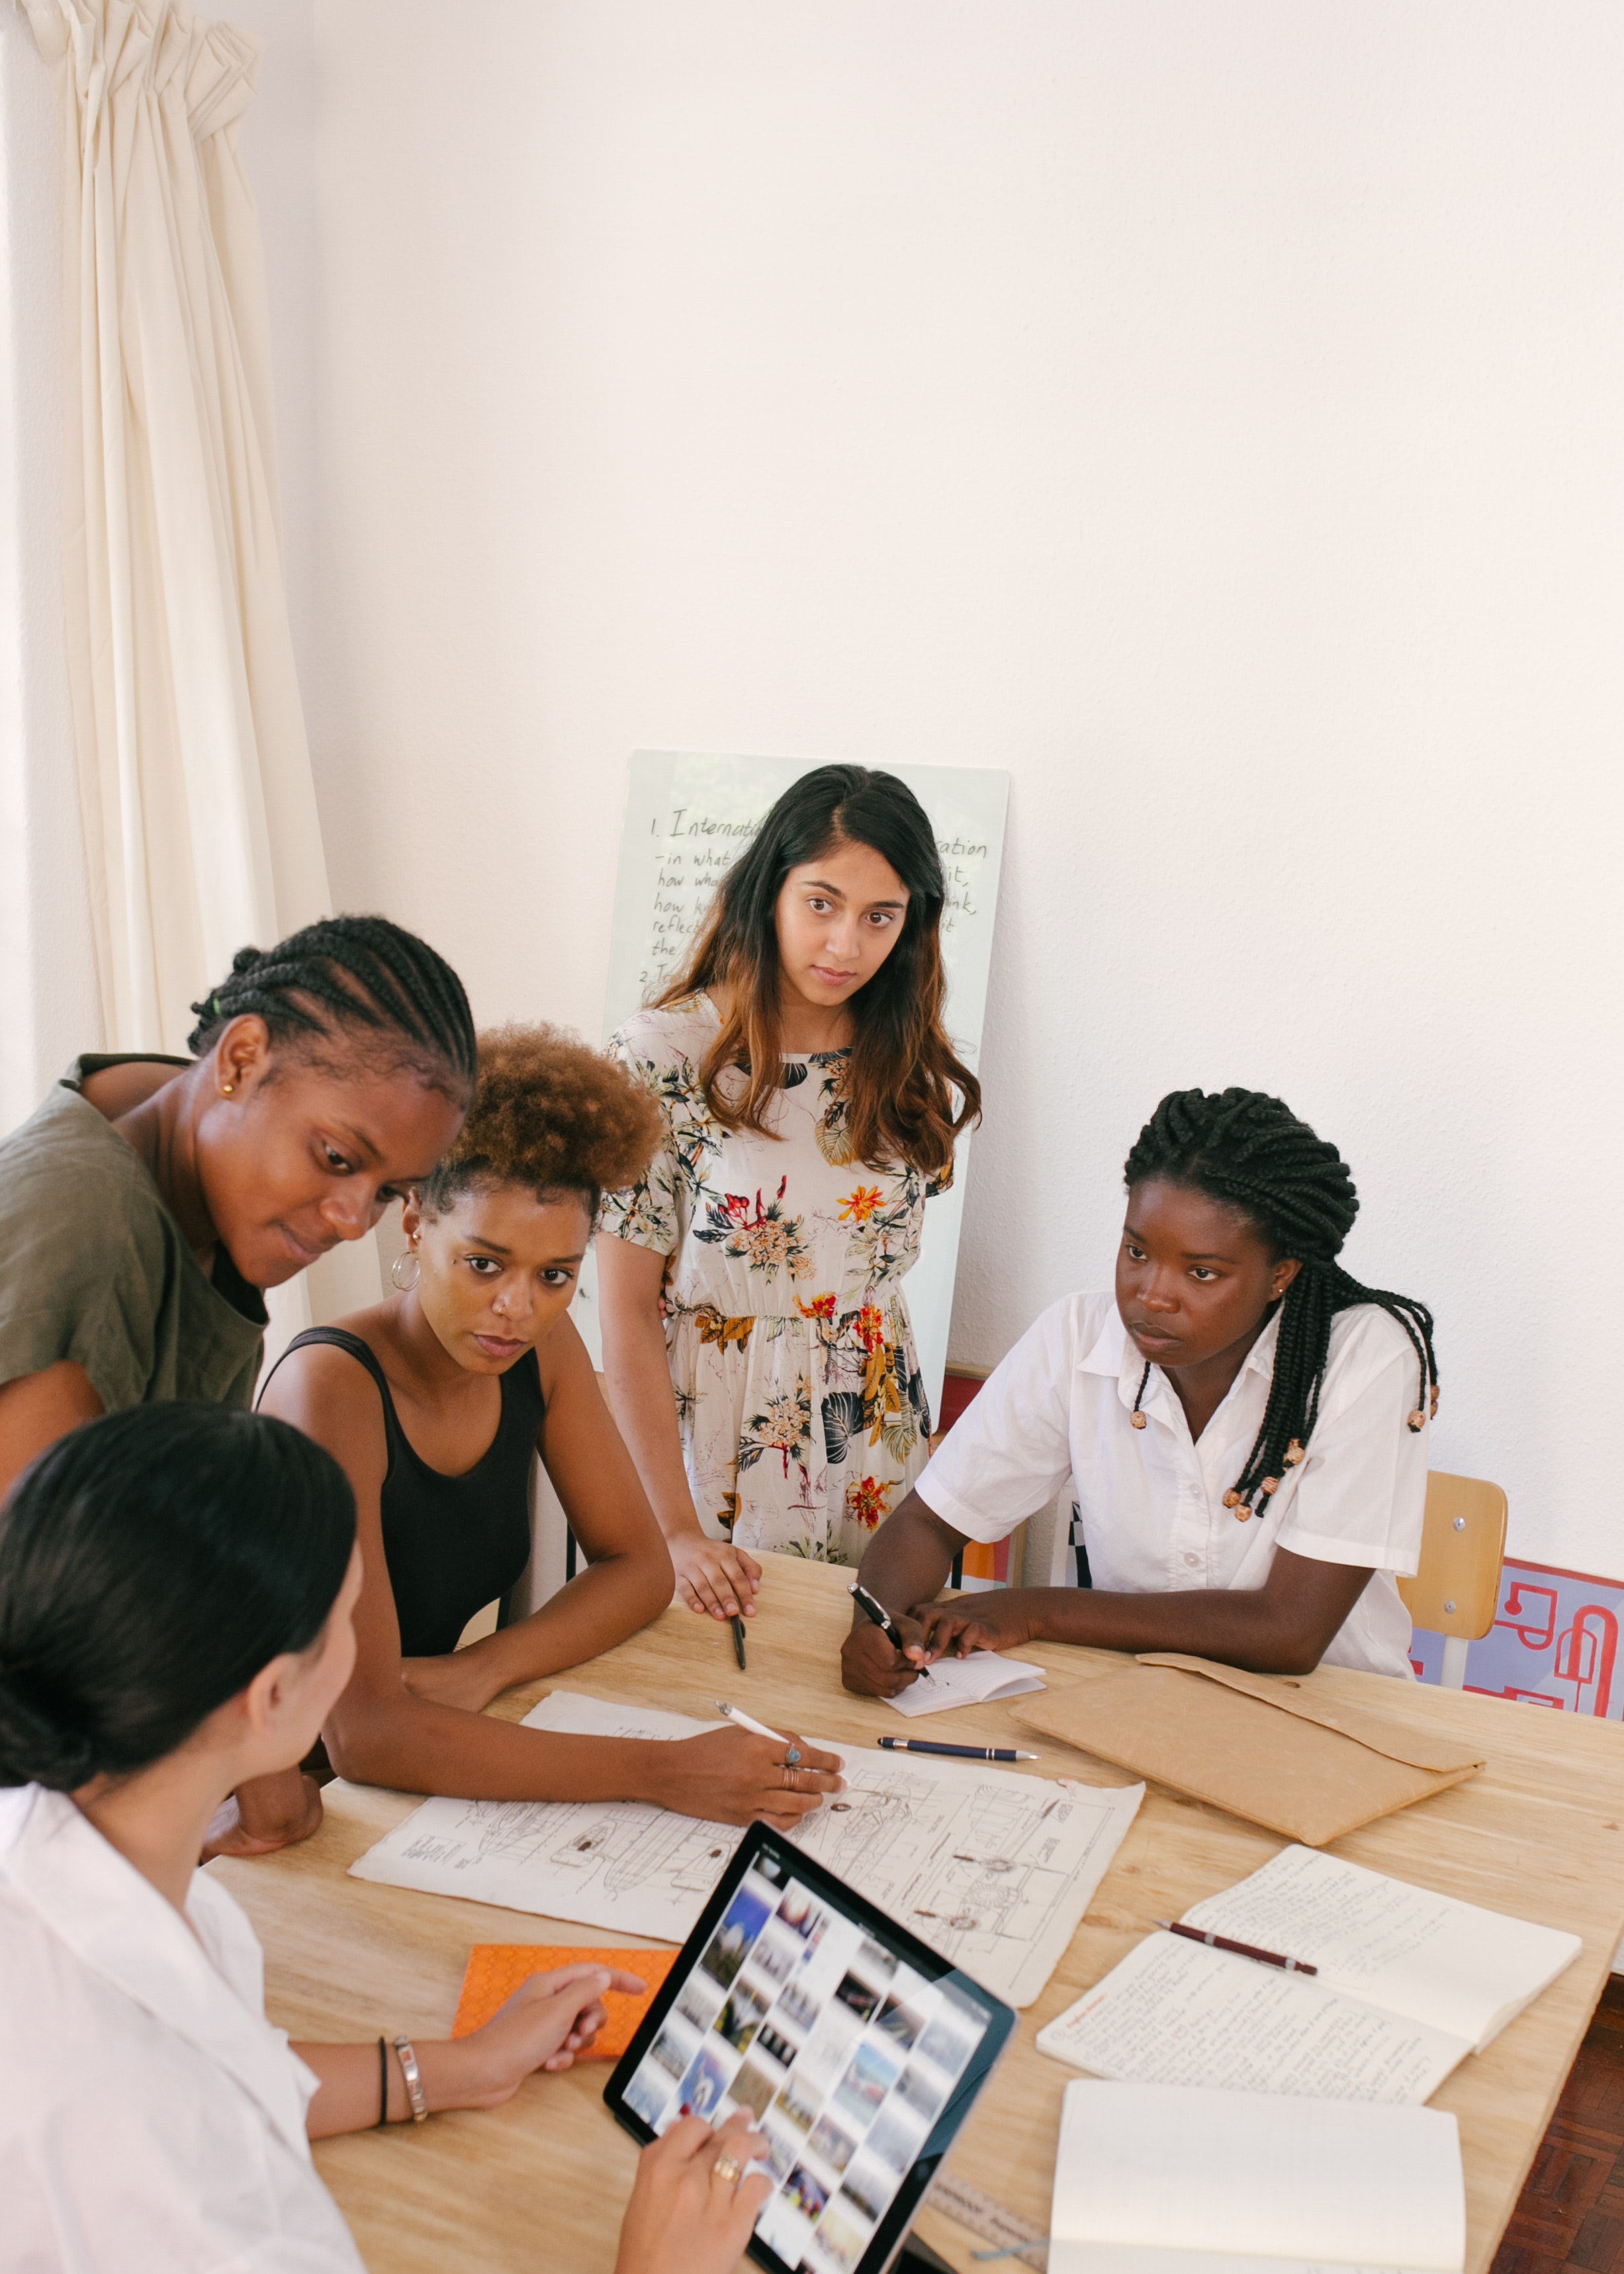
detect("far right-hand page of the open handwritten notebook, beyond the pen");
top-left (1185, 1846), bottom-right (1581, 2051)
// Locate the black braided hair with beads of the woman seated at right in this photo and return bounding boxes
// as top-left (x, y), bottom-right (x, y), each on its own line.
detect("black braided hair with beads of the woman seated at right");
top-left (1124, 1089), bottom-right (1437, 1524)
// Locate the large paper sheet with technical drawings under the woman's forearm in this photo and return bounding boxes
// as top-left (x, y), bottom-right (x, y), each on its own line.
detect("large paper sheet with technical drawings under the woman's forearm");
top-left (350, 1690), bottom-right (1144, 2006)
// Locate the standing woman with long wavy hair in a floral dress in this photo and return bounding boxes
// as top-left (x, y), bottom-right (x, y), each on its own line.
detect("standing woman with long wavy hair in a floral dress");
top-left (598, 766), bottom-right (980, 1619)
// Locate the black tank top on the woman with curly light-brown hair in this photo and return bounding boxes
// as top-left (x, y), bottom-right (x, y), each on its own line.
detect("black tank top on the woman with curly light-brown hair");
top-left (261, 1326), bottom-right (546, 1658)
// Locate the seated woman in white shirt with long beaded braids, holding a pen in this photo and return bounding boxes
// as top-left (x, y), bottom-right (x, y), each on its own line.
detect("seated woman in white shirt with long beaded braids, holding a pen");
top-left (842, 1089), bottom-right (1437, 1696)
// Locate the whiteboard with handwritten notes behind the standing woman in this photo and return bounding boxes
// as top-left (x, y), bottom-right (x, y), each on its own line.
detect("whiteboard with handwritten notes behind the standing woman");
top-left (576, 750), bottom-right (1010, 1414)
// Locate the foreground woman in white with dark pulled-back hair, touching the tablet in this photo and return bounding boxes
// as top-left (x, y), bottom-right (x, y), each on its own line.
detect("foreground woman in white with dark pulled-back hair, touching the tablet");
top-left (0, 1403), bottom-right (766, 2274)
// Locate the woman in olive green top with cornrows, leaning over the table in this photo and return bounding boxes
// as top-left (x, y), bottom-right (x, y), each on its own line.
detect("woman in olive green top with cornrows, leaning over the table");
top-left (0, 917), bottom-right (475, 1856)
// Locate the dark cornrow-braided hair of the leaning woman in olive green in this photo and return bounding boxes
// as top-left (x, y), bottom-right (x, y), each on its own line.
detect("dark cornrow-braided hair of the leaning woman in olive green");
top-left (189, 917), bottom-right (478, 1103)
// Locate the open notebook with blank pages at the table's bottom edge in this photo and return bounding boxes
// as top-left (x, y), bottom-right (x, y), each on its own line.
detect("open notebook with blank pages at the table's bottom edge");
top-left (1048, 2083), bottom-right (1467, 2274)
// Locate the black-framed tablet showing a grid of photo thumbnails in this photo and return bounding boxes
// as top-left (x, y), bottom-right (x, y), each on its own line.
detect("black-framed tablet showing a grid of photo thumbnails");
top-left (603, 1824), bottom-right (1015, 2274)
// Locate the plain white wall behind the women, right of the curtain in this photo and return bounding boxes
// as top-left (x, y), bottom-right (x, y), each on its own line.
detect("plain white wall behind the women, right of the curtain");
top-left (234, 0), bottom-right (1624, 1576)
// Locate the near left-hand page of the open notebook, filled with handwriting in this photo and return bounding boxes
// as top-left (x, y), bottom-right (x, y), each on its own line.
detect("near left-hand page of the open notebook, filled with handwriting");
top-left (1037, 1935), bottom-right (1472, 2106)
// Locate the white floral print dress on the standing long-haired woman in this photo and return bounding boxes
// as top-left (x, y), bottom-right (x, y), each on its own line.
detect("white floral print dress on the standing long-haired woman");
top-left (598, 994), bottom-right (951, 1565)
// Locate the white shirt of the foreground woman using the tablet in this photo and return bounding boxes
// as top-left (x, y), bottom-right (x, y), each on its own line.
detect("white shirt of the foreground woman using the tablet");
top-left (0, 1785), bottom-right (361, 2274)
